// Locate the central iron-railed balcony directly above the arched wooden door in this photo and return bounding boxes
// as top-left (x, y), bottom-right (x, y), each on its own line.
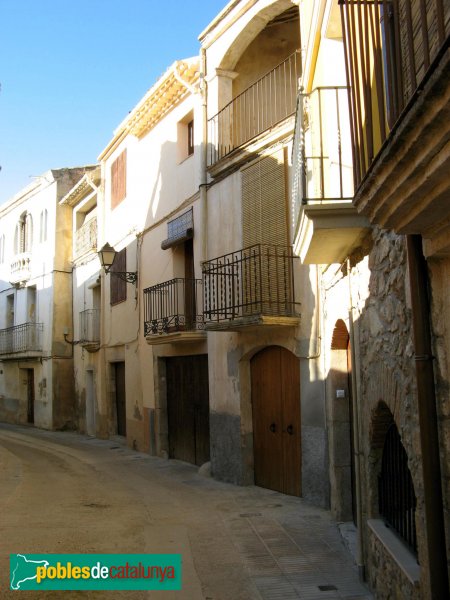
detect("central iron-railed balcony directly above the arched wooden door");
top-left (202, 244), bottom-right (300, 331)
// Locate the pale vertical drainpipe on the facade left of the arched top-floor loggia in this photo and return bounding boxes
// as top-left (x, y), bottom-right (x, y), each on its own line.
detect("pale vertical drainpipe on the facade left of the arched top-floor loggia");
top-left (200, 48), bottom-right (208, 262)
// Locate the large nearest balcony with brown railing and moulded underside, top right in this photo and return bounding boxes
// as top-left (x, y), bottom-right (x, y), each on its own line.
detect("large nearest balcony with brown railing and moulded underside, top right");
top-left (340, 0), bottom-right (450, 256)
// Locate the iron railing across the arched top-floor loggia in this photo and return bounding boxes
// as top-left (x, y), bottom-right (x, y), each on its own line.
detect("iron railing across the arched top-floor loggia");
top-left (208, 51), bottom-right (301, 166)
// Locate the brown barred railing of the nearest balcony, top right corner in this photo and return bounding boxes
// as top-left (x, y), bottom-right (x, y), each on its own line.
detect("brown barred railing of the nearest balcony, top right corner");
top-left (339, 0), bottom-right (450, 187)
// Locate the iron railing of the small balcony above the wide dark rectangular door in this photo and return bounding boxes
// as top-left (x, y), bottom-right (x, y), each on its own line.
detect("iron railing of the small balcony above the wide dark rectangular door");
top-left (144, 277), bottom-right (204, 335)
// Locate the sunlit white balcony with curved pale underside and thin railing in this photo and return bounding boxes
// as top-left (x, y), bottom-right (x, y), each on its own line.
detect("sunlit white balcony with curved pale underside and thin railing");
top-left (293, 87), bottom-right (369, 264)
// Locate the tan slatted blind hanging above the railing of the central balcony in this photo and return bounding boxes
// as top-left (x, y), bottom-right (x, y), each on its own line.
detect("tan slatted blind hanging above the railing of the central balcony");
top-left (242, 149), bottom-right (289, 248)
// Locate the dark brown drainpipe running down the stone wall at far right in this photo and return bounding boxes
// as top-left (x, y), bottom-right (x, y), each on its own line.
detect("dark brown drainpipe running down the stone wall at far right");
top-left (406, 235), bottom-right (449, 600)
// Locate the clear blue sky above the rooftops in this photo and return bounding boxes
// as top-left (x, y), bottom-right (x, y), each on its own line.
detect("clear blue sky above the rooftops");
top-left (0, 0), bottom-right (227, 204)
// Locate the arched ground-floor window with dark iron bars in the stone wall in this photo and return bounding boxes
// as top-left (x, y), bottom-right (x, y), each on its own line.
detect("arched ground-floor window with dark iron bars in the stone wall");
top-left (378, 423), bottom-right (417, 554)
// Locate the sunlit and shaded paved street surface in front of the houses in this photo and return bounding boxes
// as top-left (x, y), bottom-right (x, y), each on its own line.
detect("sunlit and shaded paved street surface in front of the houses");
top-left (0, 425), bottom-right (372, 600)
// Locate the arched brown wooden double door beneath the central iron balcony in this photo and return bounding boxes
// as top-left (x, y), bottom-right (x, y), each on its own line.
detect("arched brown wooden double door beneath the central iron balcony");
top-left (250, 346), bottom-right (301, 496)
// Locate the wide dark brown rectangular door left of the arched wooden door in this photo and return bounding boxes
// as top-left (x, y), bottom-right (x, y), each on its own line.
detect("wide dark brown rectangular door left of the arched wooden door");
top-left (166, 354), bottom-right (209, 465)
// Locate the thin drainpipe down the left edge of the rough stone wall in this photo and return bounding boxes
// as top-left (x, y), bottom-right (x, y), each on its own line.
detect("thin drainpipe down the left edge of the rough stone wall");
top-left (347, 259), bottom-right (366, 581)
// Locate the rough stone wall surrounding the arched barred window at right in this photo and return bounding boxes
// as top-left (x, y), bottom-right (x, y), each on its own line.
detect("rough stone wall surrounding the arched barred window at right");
top-left (351, 229), bottom-right (428, 599)
